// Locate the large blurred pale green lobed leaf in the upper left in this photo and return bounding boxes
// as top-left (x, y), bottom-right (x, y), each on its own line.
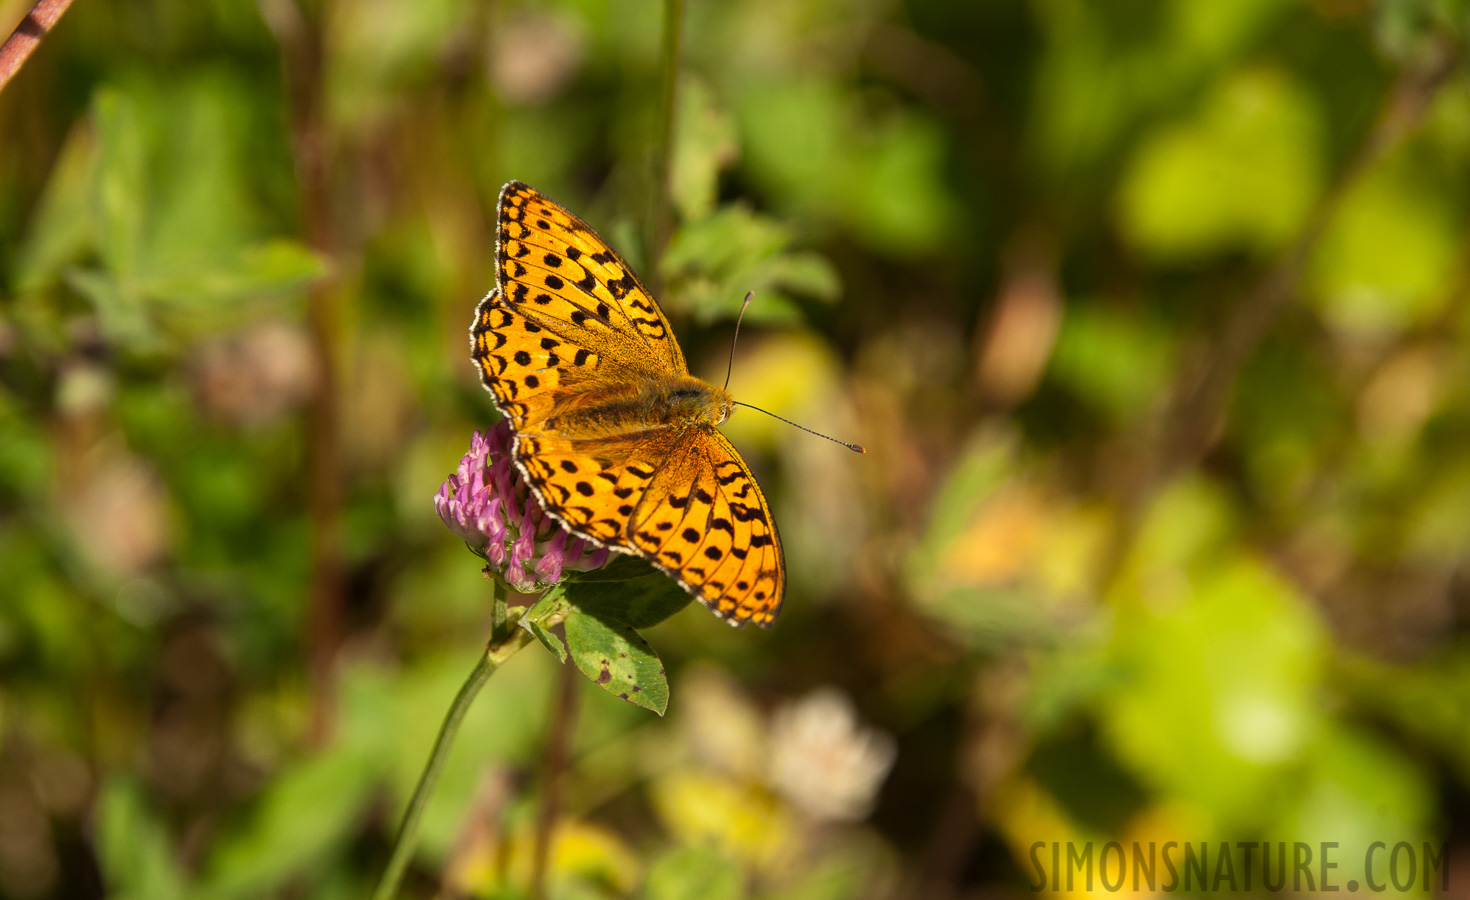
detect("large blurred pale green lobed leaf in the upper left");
top-left (49, 71), bottom-right (325, 350)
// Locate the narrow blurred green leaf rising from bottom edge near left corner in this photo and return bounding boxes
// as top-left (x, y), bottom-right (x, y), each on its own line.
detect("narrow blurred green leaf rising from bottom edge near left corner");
top-left (97, 781), bottom-right (190, 900)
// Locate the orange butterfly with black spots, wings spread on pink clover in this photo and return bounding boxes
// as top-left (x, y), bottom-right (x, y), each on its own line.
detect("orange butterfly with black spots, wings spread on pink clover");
top-left (470, 181), bottom-right (786, 626)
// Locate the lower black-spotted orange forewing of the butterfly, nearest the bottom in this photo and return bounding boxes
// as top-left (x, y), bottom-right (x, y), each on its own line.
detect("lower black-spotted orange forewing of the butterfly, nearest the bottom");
top-left (628, 426), bottom-right (786, 625)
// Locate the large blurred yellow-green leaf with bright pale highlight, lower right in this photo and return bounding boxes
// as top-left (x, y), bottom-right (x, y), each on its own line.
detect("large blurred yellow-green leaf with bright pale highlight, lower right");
top-left (1100, 547), bottom-right (1326, 831)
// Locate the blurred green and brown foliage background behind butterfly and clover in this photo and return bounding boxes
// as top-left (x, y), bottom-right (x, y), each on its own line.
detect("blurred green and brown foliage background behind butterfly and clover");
top-left (0, 0), bottom-right (1470, 900)
